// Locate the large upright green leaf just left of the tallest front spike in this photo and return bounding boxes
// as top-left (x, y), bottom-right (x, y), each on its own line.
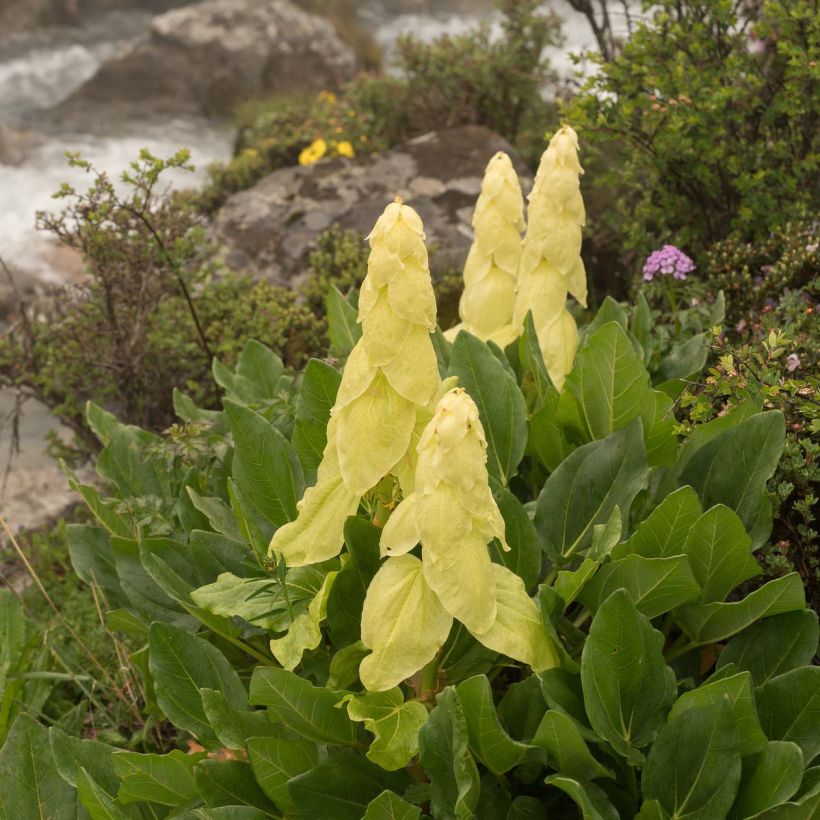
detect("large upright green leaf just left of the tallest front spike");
top-left (224, 399), bottom-right (305, 535)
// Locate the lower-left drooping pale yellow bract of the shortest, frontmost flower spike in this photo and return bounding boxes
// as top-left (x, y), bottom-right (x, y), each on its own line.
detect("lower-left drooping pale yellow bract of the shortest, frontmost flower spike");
top-left (359, 552), bottom-right (454, 692)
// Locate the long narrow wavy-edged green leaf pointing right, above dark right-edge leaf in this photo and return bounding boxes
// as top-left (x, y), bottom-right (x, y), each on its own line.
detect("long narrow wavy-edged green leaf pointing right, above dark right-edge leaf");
top-left (675, 572), bottom-right (806, 644)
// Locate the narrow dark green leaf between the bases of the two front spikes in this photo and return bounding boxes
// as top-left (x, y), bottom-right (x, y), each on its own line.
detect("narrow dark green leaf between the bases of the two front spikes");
top-left (327, 516), bottom-right (381, 647)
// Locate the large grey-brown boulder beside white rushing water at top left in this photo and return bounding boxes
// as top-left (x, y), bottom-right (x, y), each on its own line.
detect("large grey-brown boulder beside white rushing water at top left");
top-left (54, 0), bottom-right (355, 117)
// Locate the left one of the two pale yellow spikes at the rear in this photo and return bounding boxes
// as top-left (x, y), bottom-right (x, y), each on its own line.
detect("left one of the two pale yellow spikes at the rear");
top-left (445, 151), bottom-right (524, 348)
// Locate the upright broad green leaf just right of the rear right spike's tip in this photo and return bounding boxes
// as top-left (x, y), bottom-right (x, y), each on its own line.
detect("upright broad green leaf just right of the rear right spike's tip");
top-left (567, 322), bottom-right (655, 439)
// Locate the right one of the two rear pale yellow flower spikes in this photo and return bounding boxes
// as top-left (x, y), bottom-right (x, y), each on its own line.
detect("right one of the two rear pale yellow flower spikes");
top-left (513, 125), bottom-right (587, 390)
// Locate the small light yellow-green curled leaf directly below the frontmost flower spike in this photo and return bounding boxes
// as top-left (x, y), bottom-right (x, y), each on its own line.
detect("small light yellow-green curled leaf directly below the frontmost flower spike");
top-left (345, 687), bottom-right (427, 772)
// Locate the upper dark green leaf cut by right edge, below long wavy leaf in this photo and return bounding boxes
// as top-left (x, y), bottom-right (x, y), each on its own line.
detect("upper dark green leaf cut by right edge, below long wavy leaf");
top-left (717, 609), bottom-right (820, 686)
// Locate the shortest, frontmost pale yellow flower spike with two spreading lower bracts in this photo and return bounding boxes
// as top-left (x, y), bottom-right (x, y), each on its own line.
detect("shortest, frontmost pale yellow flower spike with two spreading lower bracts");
top-left (359, 388), bottom-right (557, 692)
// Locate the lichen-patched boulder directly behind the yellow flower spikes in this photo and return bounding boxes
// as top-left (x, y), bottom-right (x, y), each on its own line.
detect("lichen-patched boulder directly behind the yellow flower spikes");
top-left (214, 125), bottom-right (529, 283)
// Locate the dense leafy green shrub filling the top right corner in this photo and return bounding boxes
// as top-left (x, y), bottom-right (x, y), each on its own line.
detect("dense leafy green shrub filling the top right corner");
top-left (568, 0), bottom-right (820, 267)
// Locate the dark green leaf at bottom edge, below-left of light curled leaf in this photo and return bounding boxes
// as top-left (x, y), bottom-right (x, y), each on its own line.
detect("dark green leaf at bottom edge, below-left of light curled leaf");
top-left (288, 754), bottom-right (410, 820)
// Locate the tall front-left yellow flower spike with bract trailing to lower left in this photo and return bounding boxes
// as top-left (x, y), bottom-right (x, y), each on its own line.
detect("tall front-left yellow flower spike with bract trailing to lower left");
top-left (270, 200), bottom-right (441, 566)
